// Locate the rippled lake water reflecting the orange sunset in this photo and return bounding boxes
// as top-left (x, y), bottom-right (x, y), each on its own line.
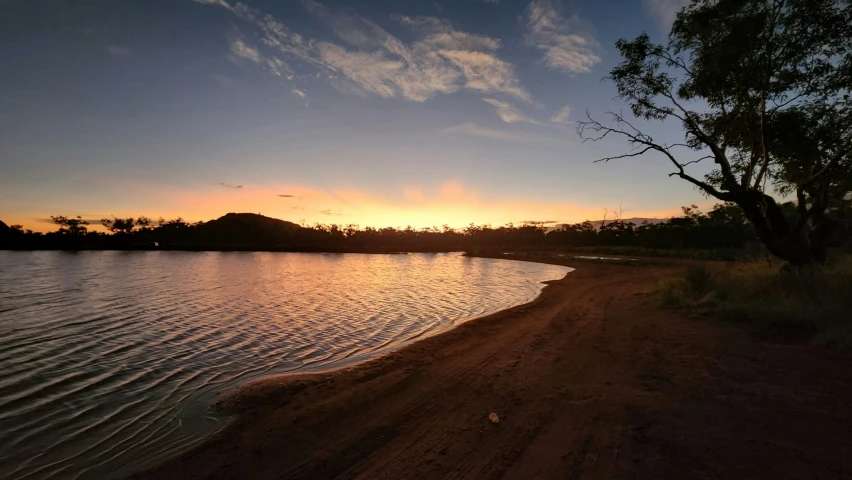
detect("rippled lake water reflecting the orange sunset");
top-left (0, 251), bottom-right (570, 479)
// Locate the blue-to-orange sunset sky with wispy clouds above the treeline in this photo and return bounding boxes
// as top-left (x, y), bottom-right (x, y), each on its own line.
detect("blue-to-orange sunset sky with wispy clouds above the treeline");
top-left (0, 0), bottom-right (708, 231)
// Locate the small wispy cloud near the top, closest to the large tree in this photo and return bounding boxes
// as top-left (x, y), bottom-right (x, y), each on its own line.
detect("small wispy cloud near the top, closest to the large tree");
top-left (526, 0), bottom-right (601, 73)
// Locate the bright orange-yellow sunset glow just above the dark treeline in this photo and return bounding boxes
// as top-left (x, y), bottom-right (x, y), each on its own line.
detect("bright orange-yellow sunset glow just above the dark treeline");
top-left (0, 181), bottom-right (703, 232)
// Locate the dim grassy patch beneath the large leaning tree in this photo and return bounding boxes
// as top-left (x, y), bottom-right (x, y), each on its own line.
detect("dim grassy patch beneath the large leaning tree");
top-left (656, 255), bottom-right (852, 349)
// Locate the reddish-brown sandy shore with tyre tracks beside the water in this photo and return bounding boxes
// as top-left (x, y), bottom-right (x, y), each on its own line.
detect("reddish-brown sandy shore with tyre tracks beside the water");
top-left (137, 256), bottom-right (852, 479)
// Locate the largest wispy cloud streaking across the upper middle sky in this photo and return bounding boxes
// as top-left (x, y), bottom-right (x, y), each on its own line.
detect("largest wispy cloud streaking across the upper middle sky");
top-left (197, 0), bottom-right (532, 102)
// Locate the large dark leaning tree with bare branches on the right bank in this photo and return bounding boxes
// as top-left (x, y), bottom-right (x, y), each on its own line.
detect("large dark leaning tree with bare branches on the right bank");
top-left (578, 0), bottom-right (852, 266)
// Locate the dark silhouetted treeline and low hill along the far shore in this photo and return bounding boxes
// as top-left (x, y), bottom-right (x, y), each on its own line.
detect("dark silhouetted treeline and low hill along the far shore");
top-left (0, 204), bottom-right (850, 253)
